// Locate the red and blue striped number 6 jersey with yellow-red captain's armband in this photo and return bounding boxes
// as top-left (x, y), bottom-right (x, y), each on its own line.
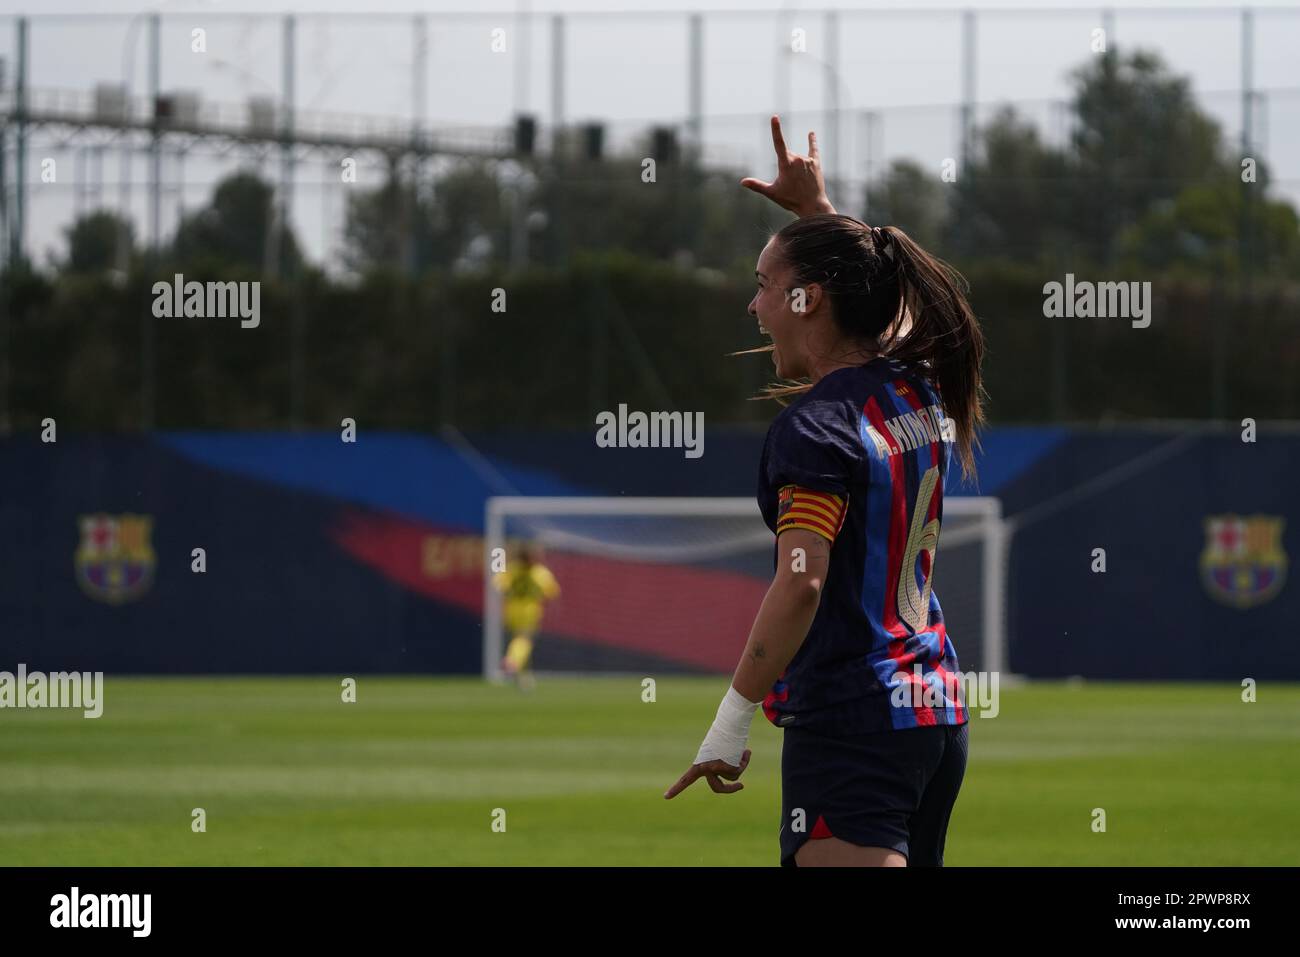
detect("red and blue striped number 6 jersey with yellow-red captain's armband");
top-left (758, 358), bottom-right (967, 735)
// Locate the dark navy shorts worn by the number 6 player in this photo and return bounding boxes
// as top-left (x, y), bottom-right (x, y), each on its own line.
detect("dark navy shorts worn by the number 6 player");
top-left (781, 723), bottom-right (970, 867)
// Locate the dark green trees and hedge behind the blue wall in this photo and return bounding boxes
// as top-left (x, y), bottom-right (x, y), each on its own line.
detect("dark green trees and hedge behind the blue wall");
top-left (0, 52), bottom-right (1300, 429)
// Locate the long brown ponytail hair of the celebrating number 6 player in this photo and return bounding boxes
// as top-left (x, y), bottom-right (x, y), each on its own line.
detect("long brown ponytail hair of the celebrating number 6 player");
top-left (733, 213), bottom-right (984, 477)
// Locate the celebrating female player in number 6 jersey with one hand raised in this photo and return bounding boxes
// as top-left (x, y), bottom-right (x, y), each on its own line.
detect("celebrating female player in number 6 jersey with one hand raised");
top-left (664, 116), bottom-right (984, 866)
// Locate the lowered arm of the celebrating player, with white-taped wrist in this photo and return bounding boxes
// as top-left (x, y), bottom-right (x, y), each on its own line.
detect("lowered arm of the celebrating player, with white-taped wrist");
top-left (664, 528), bottom-right (831, 798)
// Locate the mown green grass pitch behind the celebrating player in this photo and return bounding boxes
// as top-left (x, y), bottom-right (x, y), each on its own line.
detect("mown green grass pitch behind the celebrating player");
top-left (0, 677), bottom-right (1300, 866)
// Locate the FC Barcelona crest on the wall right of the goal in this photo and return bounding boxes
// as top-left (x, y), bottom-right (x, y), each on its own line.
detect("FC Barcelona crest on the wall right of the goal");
top-left (1201, 515), bottom-right (1287, 609)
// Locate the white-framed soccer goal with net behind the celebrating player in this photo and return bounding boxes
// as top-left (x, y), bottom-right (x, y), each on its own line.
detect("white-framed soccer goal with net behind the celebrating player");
top-left (482, 495), bottom-right (1006, 680)
